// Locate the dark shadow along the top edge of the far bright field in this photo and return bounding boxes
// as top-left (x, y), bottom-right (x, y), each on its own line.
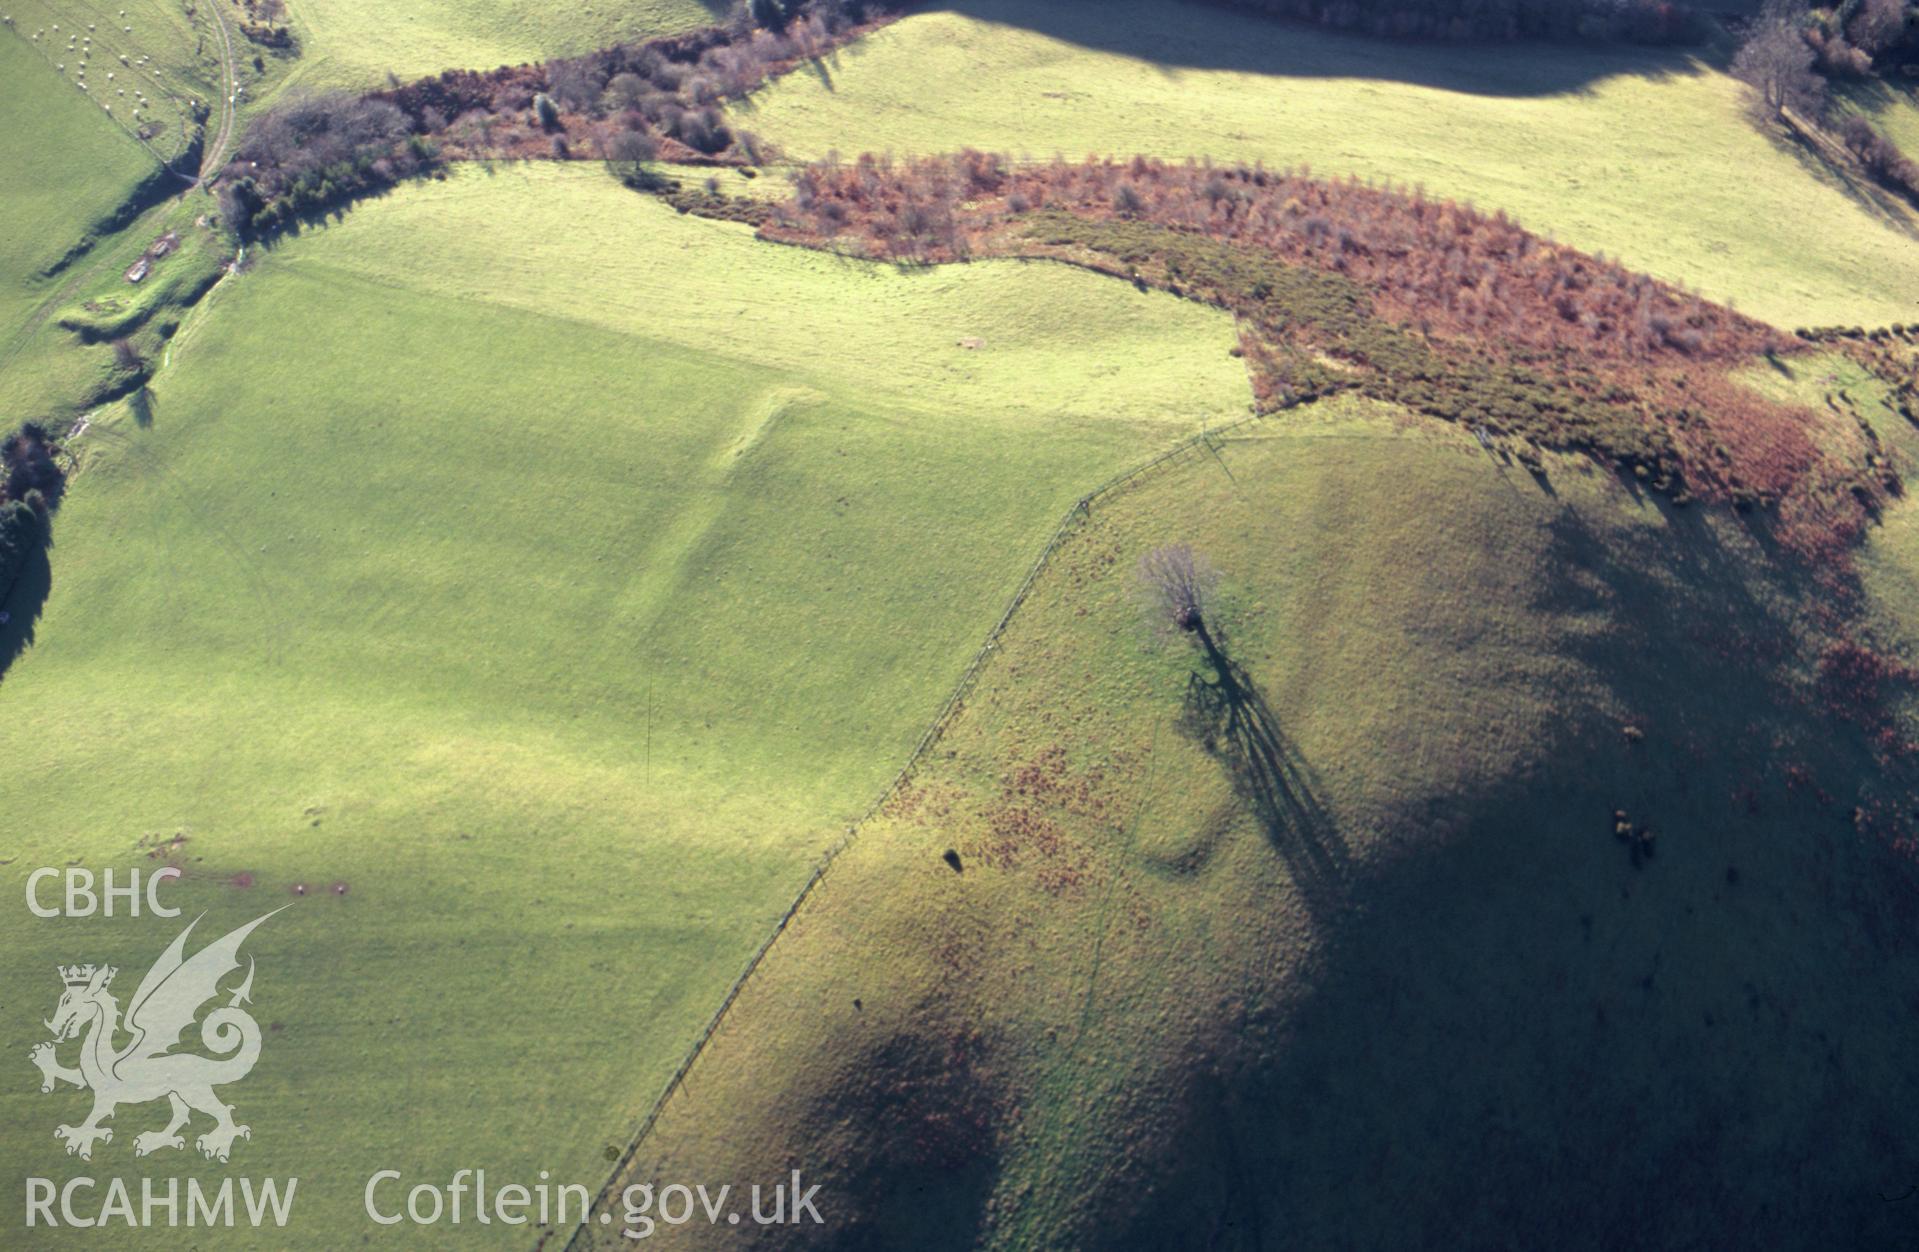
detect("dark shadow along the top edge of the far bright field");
top-left (921, 0), bottom-right (1710, 96)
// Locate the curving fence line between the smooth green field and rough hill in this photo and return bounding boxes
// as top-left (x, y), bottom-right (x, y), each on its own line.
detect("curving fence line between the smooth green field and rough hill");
top-left (560, 399), bottom-right (1311, 1252)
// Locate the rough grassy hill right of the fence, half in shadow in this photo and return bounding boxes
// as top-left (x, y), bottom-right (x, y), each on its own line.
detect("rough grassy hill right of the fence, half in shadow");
top-left (621, 395), bottom-right (1919, 1248)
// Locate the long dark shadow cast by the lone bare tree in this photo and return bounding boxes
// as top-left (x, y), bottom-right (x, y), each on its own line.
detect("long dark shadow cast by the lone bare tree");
top-left (1180, 630), bottom-right (1353, 916)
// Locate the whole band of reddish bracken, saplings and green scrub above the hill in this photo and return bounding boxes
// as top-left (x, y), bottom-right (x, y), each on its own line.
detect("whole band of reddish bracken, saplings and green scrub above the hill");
top-left (762, 152), bottom-right (1900, 551)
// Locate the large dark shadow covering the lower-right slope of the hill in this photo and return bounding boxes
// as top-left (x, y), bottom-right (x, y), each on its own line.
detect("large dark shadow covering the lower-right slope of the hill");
top-left (1105, 495), bottom-right (1919, 1248)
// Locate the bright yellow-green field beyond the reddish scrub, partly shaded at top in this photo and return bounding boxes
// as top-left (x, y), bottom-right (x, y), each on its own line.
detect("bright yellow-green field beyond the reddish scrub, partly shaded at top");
top-left (737, 0), bottom-right (1919, 328)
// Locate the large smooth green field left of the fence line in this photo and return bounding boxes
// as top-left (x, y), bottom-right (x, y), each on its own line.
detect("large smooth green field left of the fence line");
top-left (0, 167), bottom-right (1247, 1246)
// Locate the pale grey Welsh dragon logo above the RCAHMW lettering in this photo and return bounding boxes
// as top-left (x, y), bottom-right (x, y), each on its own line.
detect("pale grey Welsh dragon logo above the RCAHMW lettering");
top-left (27, 908), bottom-right (278, 1162)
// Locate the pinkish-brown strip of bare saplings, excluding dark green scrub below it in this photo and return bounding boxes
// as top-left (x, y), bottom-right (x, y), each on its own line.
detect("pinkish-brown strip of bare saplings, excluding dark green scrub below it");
top-left (783, 152), bottom-right (1781, 359)
